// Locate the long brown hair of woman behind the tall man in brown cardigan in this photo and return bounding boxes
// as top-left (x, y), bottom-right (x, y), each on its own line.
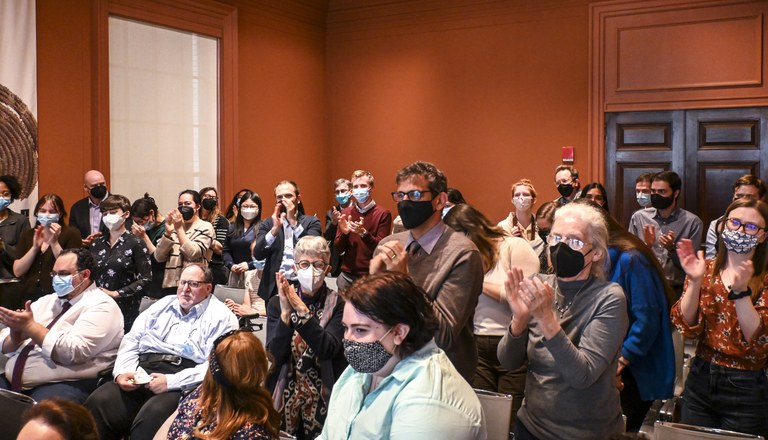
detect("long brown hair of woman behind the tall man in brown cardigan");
top-left (443, 204), bottom-right (507, 271)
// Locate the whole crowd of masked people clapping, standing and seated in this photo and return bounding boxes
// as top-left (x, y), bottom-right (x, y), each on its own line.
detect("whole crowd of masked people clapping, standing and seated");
top-left (0, 162), bottom-right (768, 440)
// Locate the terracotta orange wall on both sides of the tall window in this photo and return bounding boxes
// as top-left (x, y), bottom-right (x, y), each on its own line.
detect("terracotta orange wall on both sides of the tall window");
top-left (37, 0), bottom-right (328, 212)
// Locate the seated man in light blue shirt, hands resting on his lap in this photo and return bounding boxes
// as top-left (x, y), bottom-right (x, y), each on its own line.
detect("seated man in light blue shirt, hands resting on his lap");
top-left (85, 264), bottom-right (237, 440)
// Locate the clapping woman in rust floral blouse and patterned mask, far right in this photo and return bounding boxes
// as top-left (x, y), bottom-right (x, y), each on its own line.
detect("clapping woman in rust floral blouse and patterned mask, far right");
top-left (672, 197), bottom-right (768, 437)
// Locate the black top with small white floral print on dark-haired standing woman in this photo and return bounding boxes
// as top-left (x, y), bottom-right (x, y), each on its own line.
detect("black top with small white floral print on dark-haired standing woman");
top-left (91, 231), bottom-right (152, 333)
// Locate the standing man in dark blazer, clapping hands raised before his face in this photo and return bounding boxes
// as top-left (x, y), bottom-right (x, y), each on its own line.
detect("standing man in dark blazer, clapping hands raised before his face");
top-left (253, 180), bottom-right (322, 302)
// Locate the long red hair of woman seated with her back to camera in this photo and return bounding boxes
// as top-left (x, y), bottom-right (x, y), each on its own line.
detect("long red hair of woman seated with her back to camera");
top-left (192, 331), bottom-right (280, 440)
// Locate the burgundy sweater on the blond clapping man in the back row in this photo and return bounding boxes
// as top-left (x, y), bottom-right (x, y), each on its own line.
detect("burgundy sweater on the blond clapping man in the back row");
top-left (333, 203), bottom-right (392, 276)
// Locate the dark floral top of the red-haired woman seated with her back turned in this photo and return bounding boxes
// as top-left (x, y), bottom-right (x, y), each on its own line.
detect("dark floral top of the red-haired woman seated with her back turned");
top-left (168, 386), bottom-right (274, 440)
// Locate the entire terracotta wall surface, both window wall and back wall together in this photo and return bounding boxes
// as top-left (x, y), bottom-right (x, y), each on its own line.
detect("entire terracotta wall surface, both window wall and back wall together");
top-left (37, 0), bottom-right (591, 219)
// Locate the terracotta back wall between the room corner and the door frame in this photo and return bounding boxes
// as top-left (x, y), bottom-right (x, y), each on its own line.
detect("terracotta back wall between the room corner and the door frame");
top-left (327, 1), bottom-right (591, 220)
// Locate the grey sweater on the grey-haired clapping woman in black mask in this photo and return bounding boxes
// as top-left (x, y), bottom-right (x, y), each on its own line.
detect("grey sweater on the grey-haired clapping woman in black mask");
top-left (498, 275), bottom-right (629, 440)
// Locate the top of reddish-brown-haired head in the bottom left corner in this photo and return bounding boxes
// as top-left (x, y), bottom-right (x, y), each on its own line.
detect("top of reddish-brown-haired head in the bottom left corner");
top-left (16, 399), bottom-right (99, 440)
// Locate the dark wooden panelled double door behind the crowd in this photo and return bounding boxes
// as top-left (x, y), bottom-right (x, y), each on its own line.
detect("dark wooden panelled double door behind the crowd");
top-left (605, 107), bottom-right (768, 227)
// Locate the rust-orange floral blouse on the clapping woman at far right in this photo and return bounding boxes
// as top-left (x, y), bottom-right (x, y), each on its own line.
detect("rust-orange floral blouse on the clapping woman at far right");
top-left (671, 260), bottom-right (768, 371)
